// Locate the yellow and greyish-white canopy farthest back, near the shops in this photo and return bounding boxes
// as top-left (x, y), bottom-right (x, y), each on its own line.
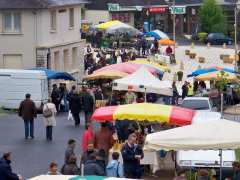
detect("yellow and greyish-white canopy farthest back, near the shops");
top-left (96, 20), bottom-right (141, 35)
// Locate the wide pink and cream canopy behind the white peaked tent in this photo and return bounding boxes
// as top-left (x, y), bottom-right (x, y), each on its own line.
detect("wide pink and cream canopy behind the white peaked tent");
top-left (94, 62), bottom-right (164, 75)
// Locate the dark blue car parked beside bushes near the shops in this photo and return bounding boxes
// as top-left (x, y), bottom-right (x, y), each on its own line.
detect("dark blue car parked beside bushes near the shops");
top-left (205, 33), bottom-right (233, 45)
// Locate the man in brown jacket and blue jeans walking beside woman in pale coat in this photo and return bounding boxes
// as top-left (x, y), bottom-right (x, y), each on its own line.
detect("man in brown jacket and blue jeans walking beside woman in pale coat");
top-left (18, 94), bottom-right (37, 139)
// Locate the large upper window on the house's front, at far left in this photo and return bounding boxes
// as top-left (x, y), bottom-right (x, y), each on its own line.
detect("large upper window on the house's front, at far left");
top-left (3, 12), bottom-right (21, 33)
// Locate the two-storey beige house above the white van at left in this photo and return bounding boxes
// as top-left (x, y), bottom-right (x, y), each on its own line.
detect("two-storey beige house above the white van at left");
top-left (0, 0), bottom-right (85, 79)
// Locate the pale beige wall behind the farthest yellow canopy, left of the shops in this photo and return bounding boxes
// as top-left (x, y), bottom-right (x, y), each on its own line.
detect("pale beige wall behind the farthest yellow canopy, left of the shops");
top-left (85, 10), bottom-right (111, 25)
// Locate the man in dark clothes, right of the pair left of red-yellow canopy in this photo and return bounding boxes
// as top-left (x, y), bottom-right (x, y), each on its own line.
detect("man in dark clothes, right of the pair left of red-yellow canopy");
top-left (82, 87), bottom-right (94, 124)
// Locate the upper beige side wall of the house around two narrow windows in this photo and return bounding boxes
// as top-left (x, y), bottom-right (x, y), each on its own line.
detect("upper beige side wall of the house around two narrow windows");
top-left (38, 6), bottom-right (81, 46)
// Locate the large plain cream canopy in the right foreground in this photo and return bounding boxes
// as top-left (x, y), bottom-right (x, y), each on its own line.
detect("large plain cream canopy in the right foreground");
top-left (144, 119), bottom-right (240, 151)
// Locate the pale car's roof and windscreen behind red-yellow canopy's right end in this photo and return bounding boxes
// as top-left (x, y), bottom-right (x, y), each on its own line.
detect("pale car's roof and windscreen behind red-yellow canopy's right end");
top-left (181, 97), bottom-right (217, 112)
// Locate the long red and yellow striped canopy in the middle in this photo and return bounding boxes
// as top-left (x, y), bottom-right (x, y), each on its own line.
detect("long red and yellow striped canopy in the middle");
top-left (92, 103), bottom-right (195, 126)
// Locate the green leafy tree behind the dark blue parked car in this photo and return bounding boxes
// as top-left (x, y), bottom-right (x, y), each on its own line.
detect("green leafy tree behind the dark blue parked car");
top-left (199, 0), bottom-right (226, 33)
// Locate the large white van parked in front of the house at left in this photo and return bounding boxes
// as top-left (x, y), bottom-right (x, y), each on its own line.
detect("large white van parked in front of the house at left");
top-left (0, 69), bottom-right (48, 109)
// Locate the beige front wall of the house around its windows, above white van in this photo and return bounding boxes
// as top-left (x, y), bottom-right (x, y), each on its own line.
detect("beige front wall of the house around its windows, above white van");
top-left (0, 10), bottom-right (36, 69)
